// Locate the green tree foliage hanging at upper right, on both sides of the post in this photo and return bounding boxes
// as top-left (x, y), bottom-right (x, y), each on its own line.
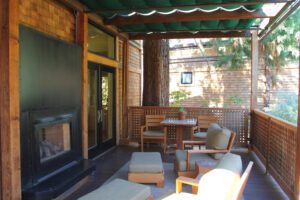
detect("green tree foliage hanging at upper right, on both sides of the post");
top-left (212, 8), bottom-right (300, 69)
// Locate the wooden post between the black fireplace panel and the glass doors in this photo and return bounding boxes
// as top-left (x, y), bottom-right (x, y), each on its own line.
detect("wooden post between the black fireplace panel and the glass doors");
top-left (76, 12), bottom-right (88, 159)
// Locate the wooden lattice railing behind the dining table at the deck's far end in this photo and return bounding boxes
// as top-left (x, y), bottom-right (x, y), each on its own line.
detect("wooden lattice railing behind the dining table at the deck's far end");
top-left (125, 106), bottom-right (249, 146)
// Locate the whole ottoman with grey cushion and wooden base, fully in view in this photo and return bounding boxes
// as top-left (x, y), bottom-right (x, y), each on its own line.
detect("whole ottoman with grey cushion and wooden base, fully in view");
top-left (128, 152), bottom-right (165, 187)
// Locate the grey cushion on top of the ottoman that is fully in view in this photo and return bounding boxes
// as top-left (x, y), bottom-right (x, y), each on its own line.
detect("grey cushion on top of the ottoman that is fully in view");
top-left (129, 152), bottom-right (163, 173)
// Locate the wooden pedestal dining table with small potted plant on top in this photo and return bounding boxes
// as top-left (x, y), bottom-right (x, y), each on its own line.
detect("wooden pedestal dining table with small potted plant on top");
top-left (160, 118), bottom-right (197, 149)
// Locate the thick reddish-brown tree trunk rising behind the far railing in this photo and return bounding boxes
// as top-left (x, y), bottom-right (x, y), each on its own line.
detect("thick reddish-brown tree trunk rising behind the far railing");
top-left (143, 40), bottom-right (169, 106)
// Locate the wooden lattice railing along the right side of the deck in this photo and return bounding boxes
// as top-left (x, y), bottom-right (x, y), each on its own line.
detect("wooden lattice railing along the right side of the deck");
top-left (251, 110), bottom-right (297, 197)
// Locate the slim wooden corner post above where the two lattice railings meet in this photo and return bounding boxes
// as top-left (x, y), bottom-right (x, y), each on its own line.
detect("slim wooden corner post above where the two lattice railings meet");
top-left (250, 30), bottom-right (259, 112)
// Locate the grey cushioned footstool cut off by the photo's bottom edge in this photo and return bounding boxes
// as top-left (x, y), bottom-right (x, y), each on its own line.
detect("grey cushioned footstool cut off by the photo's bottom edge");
top-left (78, 179), bottom-right (153, 200)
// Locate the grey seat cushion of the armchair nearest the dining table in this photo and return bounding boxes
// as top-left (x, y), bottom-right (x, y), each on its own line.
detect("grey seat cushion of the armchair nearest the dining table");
top-left (175, 150), bottom-right (218, 172)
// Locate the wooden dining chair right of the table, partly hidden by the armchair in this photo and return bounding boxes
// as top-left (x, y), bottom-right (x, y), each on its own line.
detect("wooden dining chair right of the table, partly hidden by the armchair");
top-left (191, 115), bottom-right (218, 140)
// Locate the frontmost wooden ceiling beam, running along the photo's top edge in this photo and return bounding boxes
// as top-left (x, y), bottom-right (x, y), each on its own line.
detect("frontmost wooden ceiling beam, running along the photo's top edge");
top-left (87, 0), bottom-right (293, 13)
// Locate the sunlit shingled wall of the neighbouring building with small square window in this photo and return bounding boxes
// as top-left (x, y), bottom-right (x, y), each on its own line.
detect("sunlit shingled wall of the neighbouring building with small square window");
top-left (170, 48), bottom-right (299, 108)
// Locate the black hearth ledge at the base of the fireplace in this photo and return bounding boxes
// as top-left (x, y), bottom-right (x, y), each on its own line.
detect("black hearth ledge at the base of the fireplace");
top-left (22, 159), bottom-right (96, 200)
